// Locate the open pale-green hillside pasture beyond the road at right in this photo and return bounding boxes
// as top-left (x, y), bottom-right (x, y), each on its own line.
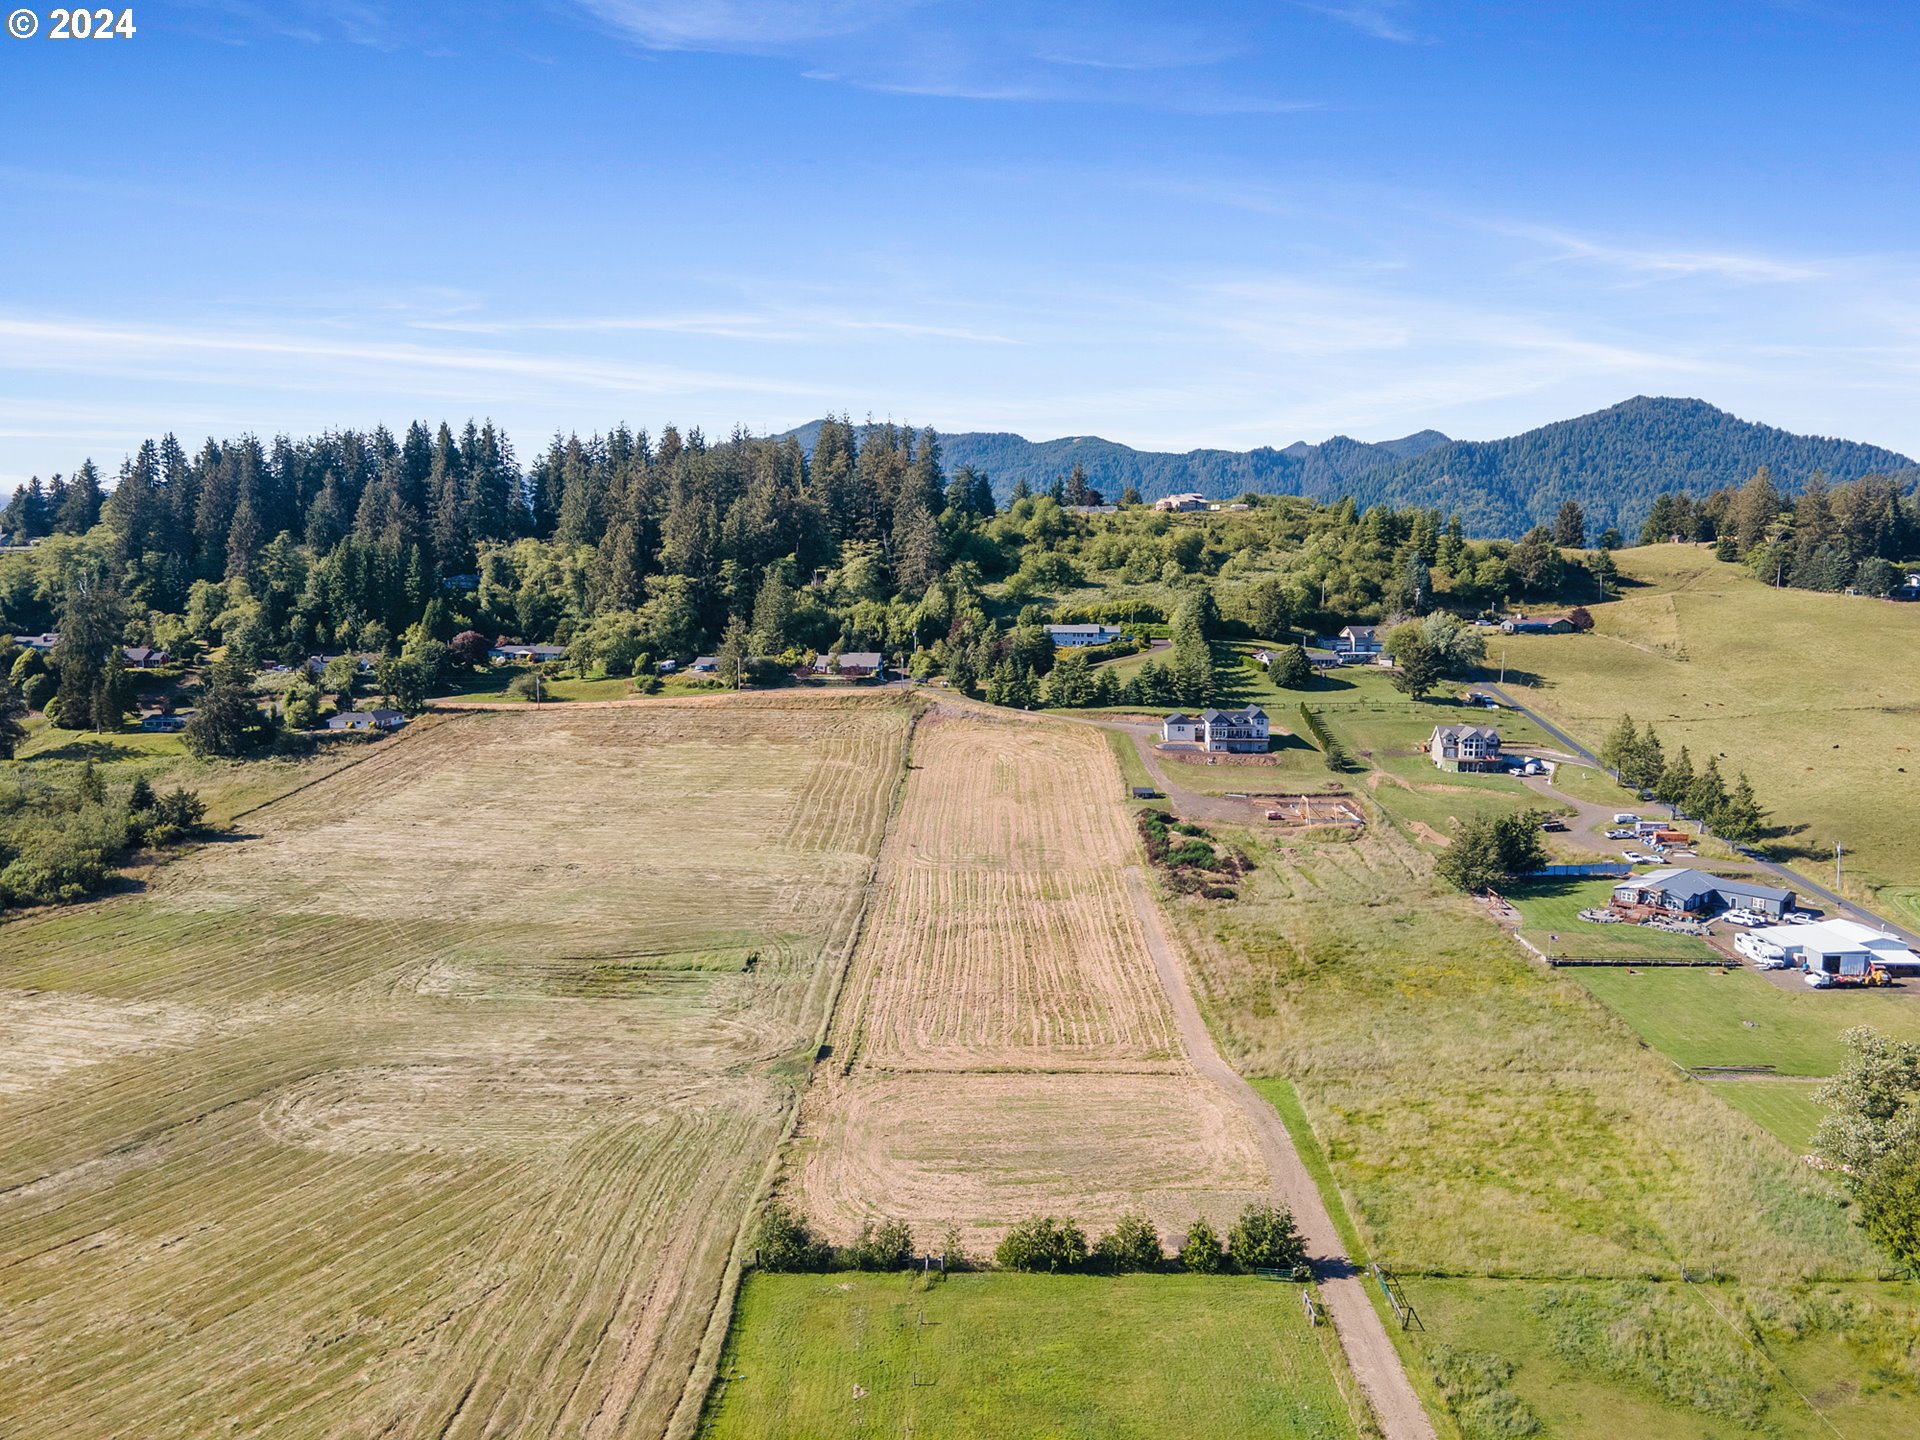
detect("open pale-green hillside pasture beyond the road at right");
top-left (1488, 545), bottom-right (1920, 924)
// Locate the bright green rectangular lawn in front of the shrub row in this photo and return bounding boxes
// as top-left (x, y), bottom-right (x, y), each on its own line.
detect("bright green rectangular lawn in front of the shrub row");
top-left (701, 1275), bottom-right (1357, 1440)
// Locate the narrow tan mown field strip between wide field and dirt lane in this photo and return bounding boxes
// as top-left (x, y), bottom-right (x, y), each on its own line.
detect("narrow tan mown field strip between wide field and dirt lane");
top-left (793, 712), bottom-right (1267, 1246)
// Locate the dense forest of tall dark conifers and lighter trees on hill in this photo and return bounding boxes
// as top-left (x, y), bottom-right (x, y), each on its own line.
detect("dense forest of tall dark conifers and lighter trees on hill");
top-left (0, 419), bottom-right (1594, 735)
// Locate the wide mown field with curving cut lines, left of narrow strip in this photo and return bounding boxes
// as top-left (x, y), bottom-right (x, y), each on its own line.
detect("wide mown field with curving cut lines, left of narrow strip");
top-left (0, 701), bottom-right (908, 1440)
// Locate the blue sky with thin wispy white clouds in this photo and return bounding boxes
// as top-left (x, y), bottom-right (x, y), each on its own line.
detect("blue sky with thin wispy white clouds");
top-left (0, 0), bottom-right (1920, 484)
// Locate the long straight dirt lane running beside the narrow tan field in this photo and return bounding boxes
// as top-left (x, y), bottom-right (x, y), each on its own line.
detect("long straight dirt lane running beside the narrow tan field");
top-left (1127, 867), bottom-right (1434, 1440)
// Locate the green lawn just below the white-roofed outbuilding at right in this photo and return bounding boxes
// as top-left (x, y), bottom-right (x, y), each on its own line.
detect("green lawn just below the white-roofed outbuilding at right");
top-left (1561, 970), bottom-right (1920, 1075)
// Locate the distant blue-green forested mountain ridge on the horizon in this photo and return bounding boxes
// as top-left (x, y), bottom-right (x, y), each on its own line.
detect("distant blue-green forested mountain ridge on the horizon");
top-left (775, 396), bottom-right (1920, 540)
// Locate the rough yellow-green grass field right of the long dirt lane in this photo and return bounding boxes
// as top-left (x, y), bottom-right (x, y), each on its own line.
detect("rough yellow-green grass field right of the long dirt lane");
top-left (1152, 829), bottom-right (1914, 1440)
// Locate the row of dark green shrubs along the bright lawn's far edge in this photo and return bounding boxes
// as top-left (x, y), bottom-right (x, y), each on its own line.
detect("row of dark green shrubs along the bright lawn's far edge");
top-left (753, 1200), bottom-right (1306, 1275)
